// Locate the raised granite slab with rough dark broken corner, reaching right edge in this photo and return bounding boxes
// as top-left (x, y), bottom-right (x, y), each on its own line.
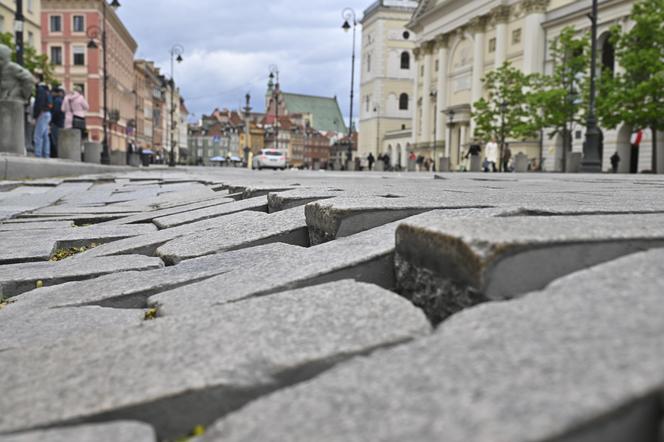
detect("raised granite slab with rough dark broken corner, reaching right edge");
top-left (395, 211), bottom-right (664, 323)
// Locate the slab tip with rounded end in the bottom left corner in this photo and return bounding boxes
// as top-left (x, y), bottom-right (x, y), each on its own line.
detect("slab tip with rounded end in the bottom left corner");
top-left (2, 421), bottom-right (157, 442)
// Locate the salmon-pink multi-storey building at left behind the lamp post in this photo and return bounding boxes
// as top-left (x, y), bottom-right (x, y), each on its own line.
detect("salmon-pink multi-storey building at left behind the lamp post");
top-left (41, 0), bottom-right (137, 158)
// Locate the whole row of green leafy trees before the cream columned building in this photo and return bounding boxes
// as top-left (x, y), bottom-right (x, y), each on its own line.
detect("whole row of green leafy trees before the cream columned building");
top-left (473, 0), bottom-right (664, 172)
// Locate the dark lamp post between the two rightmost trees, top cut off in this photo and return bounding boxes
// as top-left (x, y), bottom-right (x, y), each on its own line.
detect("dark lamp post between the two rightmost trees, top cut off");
top-left (581, 0), bottom-right (602, 173)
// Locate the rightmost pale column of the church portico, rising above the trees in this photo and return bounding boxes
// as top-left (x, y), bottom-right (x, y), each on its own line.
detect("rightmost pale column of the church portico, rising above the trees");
top-left (521, 0), bottom-right (549, 74)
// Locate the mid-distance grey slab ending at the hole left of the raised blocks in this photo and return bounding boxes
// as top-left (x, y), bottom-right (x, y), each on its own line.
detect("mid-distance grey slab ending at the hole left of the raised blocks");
top-left (157, 207), bottom-right (309, 264)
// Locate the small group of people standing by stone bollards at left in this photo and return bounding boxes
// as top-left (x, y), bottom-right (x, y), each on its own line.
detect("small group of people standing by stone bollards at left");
top-left (28, 76), bottom-right (90, 158)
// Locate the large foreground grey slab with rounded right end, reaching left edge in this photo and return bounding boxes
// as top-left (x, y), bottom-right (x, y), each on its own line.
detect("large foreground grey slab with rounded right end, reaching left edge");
top-left (0, 281), bottom-right (430, 439)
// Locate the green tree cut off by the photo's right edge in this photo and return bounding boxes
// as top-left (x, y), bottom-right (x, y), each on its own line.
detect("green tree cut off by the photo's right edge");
top-left (597, 0), bottom-right (664, 173)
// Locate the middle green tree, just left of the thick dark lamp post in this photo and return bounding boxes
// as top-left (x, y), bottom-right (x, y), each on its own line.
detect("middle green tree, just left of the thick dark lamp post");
top-left (528, 27), bottom-right (590, 170)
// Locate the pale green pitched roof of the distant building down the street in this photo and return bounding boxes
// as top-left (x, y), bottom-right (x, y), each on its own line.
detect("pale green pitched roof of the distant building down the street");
top-left (282, 93), bottom-right (348, 133)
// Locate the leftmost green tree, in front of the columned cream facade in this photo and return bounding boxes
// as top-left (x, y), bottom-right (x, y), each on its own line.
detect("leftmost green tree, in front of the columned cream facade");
top-left (472, 62), bottom-right (537, 171)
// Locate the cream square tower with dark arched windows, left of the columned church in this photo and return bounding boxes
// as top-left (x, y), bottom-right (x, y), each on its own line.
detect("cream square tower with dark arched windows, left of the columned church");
top-left (358, 0), bottom-right (418, 164)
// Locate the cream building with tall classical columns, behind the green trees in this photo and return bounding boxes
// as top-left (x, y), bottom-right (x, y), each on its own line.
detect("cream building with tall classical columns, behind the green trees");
top-left (404, 0), bottom-right (664, 172)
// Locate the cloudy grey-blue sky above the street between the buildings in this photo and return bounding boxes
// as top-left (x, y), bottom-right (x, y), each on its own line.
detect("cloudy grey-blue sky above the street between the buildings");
top-left (118, 0), bottom-right (373, 122)
